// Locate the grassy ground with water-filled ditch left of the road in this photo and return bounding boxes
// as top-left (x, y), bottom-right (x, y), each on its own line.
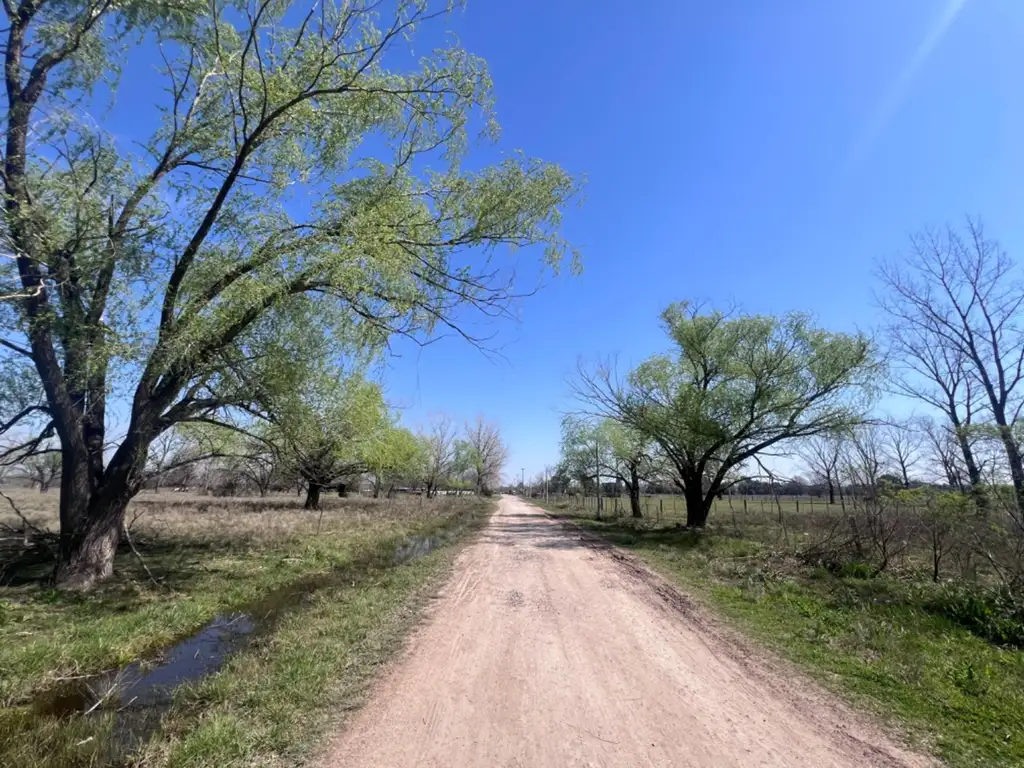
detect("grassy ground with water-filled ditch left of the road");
top-left (0, 499), bottom-right (489, 767)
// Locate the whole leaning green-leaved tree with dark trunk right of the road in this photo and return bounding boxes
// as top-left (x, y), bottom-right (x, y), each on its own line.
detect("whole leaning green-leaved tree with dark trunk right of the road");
top-left (573, 302), bottom-right (877, 526)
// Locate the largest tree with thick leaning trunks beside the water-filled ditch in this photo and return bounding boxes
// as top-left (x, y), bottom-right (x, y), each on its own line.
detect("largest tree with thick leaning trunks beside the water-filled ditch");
top-left (0, 0), bottom-right (577, 588)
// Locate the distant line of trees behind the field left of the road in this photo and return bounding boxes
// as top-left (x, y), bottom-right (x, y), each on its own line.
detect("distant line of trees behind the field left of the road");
top-left (0, 405), bottom-right (508, 510)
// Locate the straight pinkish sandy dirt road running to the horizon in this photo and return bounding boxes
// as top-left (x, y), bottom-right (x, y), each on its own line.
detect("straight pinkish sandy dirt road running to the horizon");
top-left (324, 497), bottom-right (930, 768)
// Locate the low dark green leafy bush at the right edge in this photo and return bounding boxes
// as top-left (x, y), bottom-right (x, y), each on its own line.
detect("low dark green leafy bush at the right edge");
top-left (927, 586), bottom-right (1024, 648)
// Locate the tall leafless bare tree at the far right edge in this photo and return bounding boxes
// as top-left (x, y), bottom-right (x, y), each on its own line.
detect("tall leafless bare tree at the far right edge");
top-left (880, 219), bottom-right (1024, 514)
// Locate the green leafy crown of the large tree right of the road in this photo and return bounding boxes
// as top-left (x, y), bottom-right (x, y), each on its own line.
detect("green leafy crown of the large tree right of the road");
top-left (630, 302), bottom-right (874, 460)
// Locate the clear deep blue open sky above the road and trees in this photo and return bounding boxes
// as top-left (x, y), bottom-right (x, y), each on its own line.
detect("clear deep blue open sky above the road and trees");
top-left (378, 0), bottom-right (1024, 475)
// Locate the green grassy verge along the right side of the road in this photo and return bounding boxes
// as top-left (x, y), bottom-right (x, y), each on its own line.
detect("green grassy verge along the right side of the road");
top-left (542, 504), bottom-right (1024, 767)
